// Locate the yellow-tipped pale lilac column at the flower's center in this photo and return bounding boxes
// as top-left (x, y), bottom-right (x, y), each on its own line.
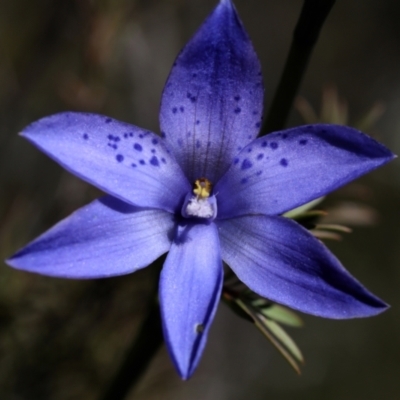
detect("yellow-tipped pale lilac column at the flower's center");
top-left (182, 178), bottom-right (217, 219)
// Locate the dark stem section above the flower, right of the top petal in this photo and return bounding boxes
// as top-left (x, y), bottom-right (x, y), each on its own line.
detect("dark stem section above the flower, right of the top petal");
top-left (260, 0), bottom-right (335, 135)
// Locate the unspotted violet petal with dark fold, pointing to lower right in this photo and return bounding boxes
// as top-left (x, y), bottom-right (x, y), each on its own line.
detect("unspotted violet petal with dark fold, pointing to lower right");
top-left (218, 215), bottom-right (387, 319)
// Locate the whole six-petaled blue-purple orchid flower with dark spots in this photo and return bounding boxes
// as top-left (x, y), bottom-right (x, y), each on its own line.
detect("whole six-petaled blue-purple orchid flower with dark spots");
top-left (7, 0), bottom-right (393, 379)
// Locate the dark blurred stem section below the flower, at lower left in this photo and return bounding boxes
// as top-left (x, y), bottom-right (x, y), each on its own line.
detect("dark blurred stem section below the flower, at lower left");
top-left (101, 288), bottom-right (163, 400)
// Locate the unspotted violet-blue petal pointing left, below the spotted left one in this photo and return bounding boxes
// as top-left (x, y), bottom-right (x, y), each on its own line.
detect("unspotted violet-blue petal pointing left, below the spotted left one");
top-left (6, 196), bottom-right (174, 278)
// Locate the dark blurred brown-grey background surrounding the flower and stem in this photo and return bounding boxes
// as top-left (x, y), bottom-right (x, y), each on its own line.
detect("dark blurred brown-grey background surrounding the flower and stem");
top-left (0, 0), bottom-right (400, 400)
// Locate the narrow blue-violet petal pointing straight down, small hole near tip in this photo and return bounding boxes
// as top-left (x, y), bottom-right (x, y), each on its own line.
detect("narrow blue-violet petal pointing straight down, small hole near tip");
top-left (160, 224), bottom-right (223, 379)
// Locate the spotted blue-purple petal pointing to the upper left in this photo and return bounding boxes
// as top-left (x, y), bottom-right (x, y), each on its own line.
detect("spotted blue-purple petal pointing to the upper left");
top-left (22, 112), bottom-right (190, 212)
